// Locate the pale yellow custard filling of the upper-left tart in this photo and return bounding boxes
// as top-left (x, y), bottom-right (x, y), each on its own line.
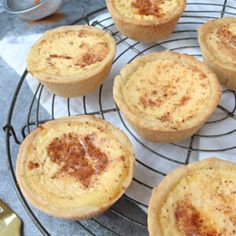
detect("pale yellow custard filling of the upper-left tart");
top-left (28, 27), bottom-right (113, 76)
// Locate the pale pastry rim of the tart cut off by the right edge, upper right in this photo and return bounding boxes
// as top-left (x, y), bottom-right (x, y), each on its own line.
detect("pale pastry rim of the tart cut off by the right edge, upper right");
top-left (198, 17), bottom-right (236, 72)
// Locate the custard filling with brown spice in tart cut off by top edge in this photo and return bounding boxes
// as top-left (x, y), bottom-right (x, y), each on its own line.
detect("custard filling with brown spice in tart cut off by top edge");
top-left (113, 0), bottom-right (178, 20)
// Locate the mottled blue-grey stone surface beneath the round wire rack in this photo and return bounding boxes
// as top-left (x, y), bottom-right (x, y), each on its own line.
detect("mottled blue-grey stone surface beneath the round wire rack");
top-left (0, 0), bottom-right (147, 236)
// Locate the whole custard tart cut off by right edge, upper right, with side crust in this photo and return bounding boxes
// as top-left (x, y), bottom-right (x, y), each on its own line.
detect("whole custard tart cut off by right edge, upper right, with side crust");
top-left (198, 17), bottom-right (236, 90)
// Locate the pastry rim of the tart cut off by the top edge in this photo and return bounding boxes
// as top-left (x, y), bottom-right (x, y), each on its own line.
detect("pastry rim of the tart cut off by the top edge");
top-left (106, 0), bottom-right (186, 26)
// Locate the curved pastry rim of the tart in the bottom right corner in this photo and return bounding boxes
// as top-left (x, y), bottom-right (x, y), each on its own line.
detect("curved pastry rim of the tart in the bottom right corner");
top-left (147, 157), bottom-right (236, 236)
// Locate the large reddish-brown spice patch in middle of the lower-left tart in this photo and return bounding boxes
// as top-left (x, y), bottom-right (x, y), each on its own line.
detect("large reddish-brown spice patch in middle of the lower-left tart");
top-left (47, 133), bottom-right (108, 188)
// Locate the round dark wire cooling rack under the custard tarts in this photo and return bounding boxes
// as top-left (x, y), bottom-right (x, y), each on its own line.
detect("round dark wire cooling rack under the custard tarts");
top-left (4, 0), bottom-right (236, 235)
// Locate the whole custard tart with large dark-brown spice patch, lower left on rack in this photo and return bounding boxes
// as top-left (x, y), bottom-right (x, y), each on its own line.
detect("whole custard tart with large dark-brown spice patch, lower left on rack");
top-left (16, 115), bottom-right (134, 220)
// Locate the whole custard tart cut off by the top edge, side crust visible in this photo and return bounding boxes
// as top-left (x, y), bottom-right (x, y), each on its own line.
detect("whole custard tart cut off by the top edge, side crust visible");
top-left (106, 0), bottom-right (186, 43)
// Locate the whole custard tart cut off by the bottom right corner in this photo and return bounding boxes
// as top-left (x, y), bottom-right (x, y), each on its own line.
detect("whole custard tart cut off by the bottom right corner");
top-left (148, 158), bottom-right (236, 236)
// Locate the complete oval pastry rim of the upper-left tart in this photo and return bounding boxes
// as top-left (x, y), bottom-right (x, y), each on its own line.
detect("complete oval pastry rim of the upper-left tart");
top-left (26, 25), bottom-right (116, 84)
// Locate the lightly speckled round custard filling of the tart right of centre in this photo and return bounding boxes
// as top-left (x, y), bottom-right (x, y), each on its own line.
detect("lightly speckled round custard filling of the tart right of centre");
top-left (121, 53), bottom-right (218, 130)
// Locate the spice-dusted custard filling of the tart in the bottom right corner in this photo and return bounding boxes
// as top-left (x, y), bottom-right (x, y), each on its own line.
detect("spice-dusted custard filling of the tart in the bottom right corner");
top-left (159, 168), bottom-right (236, 236)
